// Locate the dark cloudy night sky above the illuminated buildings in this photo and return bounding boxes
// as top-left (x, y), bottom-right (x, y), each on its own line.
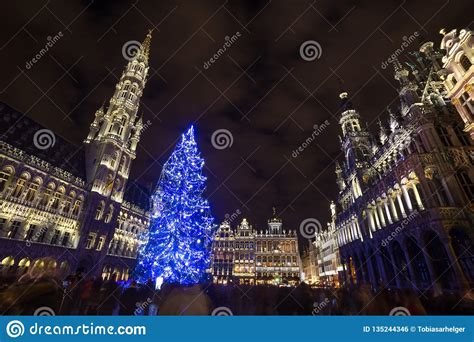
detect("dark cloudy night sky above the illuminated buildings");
top-left (0, 0), bottom-right (473, 240)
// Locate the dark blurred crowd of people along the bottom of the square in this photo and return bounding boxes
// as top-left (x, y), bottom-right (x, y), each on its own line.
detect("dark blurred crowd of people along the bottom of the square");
top-left (0, 260), bottom-right (474, 315)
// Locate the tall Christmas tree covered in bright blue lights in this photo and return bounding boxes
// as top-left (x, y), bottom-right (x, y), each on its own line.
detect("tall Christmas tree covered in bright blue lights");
top-left (135, 126), bottom-right (215, 285)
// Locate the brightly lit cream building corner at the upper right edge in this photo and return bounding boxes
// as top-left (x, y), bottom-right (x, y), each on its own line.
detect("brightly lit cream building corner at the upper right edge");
top-left (441, 30), bottom-right (474, 139)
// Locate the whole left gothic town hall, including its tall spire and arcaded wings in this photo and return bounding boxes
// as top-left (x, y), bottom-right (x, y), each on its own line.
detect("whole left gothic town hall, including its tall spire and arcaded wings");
top-left (0, 34), bottom-right (151, 280)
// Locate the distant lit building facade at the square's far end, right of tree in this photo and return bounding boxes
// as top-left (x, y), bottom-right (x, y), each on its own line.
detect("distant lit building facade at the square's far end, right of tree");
top-left (211, 210), bottom-right (301, 285)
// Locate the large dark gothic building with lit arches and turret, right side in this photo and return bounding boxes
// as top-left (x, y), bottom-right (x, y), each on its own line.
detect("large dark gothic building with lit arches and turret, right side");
top-left (335, 43), bottom-right (474, 293)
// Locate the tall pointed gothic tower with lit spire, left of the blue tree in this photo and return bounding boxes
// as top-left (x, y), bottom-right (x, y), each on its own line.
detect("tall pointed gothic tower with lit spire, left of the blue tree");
top-left (79, 31), bottom-right (151, 268)
